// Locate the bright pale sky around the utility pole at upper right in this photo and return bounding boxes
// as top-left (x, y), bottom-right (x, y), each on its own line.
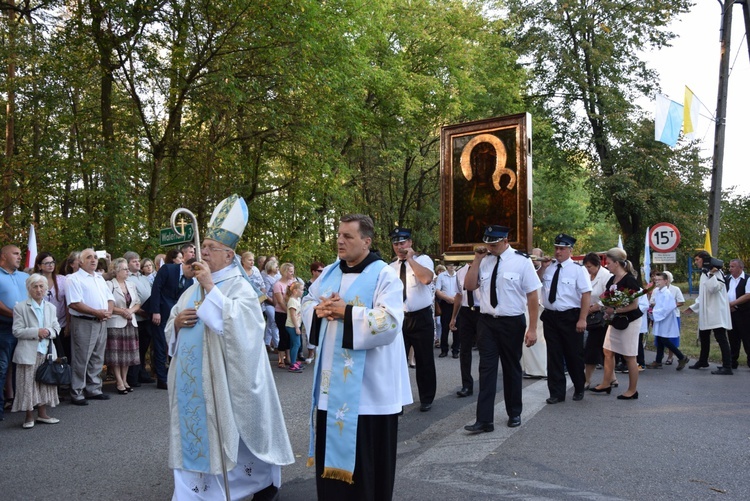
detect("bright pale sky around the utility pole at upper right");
top-left (645, 0), bottom-right (750, 195)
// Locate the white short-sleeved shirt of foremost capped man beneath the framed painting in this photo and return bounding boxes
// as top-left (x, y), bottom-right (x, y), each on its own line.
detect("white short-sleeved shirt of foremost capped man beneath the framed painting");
top-left (479, 246), bottom-right (542, 317)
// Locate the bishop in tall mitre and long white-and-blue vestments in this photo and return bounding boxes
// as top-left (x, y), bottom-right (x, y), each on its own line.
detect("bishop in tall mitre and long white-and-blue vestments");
top-left (166, 195), bottom-right (294, 501)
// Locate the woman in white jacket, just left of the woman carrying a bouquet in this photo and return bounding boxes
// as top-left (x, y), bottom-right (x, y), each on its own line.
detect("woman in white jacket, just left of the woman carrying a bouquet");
top-left (583, 252), bottom-right (617, 389)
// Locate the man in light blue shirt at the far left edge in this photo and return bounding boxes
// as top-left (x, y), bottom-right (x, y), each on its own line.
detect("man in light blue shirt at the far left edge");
top-left (0, 245), bottom-right (29, 421)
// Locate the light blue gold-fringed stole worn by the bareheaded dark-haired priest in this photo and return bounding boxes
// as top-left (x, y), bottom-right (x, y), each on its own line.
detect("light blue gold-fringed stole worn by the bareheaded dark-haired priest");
top-left (307, 260), bottom-right (387, 484)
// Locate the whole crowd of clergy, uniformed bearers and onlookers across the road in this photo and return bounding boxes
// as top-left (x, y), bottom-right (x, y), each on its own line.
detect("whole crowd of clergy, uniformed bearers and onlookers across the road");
top-left (0, 206), bottom-right (750, 499)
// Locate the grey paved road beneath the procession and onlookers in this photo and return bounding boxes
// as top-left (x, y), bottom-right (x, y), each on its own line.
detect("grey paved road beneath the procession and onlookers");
top-left (0, 344), bottom-right (750, 501)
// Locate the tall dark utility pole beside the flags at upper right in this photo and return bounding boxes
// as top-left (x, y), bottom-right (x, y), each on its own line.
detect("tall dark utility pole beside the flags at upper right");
top-left (708, 0), bottom-right (735, 255)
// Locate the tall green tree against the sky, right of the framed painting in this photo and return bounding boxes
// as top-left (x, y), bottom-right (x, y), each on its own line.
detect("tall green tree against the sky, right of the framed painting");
top-left (504, 0), bottom-right (694, 280)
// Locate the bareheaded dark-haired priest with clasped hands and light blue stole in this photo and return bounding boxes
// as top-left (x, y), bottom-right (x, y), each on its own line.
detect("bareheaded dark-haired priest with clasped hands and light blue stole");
top-left (302, 214), bottom-right (413, 501)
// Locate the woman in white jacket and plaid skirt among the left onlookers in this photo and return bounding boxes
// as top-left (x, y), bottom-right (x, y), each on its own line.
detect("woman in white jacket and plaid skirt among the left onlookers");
top-left (104, 257), bottom-right (141, 395)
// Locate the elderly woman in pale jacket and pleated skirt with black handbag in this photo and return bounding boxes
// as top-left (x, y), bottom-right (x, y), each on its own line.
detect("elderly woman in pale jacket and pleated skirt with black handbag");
top-left (11, 273), bottom-right (60, 429)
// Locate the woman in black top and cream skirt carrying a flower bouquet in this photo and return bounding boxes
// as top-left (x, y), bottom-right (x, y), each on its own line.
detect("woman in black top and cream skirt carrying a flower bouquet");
top-left (589, 247), bottom-right (643, 400)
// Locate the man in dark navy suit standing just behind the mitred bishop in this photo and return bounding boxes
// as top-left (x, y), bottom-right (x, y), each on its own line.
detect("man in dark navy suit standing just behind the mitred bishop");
top-left (150, 258), bottom-right (195, 390)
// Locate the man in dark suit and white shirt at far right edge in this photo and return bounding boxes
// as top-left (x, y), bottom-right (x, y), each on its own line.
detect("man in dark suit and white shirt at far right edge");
top-left (726, 259), bottom-right (750, 369)
